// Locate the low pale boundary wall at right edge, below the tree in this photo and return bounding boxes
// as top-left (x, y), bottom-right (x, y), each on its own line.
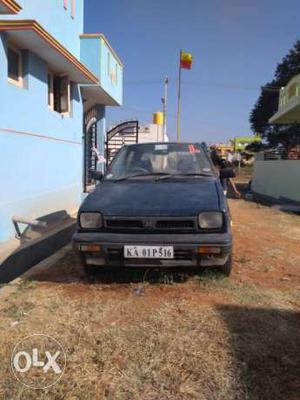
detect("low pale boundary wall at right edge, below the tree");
top-left (252, 159), bottom-right (300, 202)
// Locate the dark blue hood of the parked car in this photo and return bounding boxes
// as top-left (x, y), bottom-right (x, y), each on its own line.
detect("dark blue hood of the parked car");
top-left (81, 178), bottom-right (220, 216)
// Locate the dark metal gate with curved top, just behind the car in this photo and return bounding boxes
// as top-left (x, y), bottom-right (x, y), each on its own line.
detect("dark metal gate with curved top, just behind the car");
top-left (106, 121), bottom-right (139, 165)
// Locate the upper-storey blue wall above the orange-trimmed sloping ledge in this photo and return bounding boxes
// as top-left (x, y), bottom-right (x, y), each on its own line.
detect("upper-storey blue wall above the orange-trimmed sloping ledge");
top-left (1, 0), bottom-right (84, 59)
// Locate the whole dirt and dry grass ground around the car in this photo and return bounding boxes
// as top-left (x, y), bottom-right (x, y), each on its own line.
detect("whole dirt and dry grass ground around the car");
top-left (0, 199), bottom-right (300, 400)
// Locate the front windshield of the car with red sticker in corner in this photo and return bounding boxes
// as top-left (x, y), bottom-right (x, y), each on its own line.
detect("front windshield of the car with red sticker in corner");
top-left (105, 143), bottom-right (212, 180)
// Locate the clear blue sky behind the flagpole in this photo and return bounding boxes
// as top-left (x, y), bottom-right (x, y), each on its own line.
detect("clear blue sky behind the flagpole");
top-left (85, 0), bottom-right (300, 143)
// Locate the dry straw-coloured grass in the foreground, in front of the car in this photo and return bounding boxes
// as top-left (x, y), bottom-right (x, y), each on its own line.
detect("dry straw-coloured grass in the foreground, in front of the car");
top-left (0, 275), bottom-right (300, 400)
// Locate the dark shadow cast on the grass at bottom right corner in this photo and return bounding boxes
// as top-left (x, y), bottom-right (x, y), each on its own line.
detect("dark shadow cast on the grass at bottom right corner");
top-left (217, 305), bottom-right (300, 400)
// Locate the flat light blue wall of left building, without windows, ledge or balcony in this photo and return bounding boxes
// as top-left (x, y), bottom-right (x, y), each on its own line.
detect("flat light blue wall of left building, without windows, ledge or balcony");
top-left (0, 0), bottom-right (83, 244)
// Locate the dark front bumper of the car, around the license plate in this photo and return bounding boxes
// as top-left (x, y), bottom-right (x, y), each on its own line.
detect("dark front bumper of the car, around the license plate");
top-left (73, 232), bottom-right (232, 267)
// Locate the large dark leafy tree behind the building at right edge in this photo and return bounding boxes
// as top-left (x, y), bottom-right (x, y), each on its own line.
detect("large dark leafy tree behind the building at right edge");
top-left (249, 40), bottom-right (300, 146)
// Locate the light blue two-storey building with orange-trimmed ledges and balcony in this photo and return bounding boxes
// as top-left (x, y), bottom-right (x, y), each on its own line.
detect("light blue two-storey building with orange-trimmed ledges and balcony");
top-left (0, 0), bottom-right (123, 246)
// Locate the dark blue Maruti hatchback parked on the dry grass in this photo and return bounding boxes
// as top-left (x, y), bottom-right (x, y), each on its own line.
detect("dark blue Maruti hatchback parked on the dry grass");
top-left (73, 143), bottom-right (232, 275)
